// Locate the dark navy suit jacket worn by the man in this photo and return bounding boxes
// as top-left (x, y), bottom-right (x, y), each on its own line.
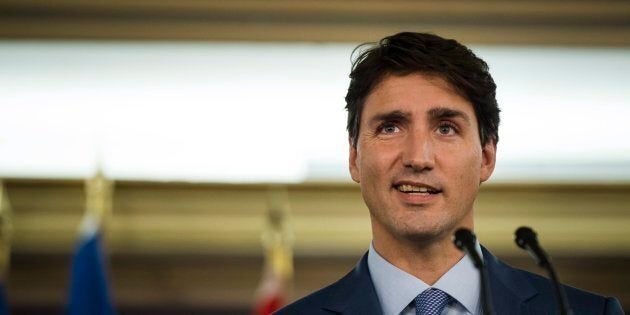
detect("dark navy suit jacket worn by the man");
top-left (275, 248), bottom-right (624, 315)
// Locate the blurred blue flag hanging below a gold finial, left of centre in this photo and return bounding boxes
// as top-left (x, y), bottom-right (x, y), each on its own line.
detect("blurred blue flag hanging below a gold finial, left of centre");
top-left (67, 218), bottom-right (115, 315)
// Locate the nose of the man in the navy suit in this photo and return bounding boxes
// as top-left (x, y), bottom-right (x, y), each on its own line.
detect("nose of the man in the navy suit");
top-left (402, 134), bottom-right (435, 172)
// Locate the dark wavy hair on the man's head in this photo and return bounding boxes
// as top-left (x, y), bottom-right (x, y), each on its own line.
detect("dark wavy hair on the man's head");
top-left (346, 32), bottom-right (500, 147)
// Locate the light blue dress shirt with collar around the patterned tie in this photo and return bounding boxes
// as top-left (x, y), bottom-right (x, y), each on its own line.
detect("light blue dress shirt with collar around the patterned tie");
top-left (368, 243), bottom-right (482, 315)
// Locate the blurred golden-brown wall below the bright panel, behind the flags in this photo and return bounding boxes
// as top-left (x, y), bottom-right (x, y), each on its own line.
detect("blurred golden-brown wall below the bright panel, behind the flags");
top-left (5, 180), bottom-right (630, 314)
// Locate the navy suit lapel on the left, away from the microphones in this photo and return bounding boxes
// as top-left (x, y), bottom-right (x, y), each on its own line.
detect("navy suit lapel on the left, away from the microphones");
top-left (323, 254), bottom-right (382, 315)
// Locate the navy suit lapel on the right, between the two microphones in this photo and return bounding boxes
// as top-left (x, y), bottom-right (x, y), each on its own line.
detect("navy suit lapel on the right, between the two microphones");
top-left (481, 247), bottom-right (542, 314)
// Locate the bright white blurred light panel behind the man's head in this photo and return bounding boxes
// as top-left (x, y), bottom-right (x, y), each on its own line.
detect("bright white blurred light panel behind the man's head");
top-left (0, 41), bottom-right (630, 182)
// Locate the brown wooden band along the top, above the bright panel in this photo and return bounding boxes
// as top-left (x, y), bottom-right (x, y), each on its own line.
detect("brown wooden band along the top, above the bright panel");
top-left (0, 0), bottom-right (630, 46)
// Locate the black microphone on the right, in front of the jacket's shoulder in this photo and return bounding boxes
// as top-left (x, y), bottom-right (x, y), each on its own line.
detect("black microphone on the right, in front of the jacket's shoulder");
top-left (514, 226), bottom-right (573, 315)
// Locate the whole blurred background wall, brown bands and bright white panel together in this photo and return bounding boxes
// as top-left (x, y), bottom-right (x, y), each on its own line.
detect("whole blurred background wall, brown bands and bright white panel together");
top-left (0, 0), bottom-right (630, 314)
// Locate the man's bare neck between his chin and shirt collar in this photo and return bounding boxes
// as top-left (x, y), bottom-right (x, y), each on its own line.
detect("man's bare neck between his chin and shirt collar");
top-left (373, 228), bottom-right (464, 285)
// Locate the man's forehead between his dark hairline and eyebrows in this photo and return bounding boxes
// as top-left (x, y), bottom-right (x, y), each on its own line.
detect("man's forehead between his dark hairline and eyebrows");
top-left (361, 73), bottom-right (476, 123)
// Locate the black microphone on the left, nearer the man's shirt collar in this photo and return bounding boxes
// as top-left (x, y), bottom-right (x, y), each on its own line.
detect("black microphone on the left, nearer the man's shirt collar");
top-left (453, 228), bottom-right (494, 315)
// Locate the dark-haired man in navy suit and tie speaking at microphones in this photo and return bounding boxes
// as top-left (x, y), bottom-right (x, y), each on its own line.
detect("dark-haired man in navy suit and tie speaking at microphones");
top-left (278, 33), bottom-right (623, 315)
